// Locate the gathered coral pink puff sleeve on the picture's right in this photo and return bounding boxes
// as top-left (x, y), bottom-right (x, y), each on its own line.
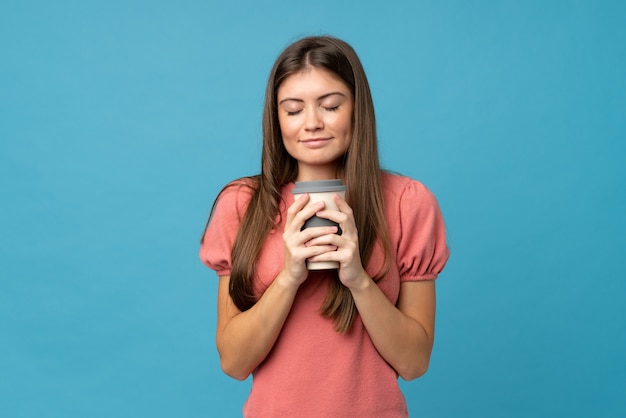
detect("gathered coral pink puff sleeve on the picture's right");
top-left (396, 180), bottom-right (450, 281)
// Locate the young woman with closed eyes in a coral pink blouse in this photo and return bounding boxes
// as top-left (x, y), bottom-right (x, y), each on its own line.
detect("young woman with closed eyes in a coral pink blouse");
top-left (200, 37), bottom-right (449, 418)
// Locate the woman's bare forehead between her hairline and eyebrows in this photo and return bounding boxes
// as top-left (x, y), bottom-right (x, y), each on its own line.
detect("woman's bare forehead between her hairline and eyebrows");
top-left (277, 67), bottom-right (351, 100)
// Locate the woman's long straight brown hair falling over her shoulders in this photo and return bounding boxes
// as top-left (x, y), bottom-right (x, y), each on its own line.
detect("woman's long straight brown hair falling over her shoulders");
top-left (205, 36), bottom-right (390, 332)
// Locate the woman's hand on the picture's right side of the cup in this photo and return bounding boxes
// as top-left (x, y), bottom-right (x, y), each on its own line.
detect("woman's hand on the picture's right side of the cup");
top-left (307, 194), bottom-right (369, 289)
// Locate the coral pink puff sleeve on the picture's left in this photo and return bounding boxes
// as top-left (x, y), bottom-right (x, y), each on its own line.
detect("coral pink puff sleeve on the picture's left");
top-left (200, 183), bottom-right (252, 276)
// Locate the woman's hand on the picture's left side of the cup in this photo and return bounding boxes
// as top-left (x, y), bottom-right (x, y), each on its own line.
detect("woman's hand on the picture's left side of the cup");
top-left (283, 193), bottom-right (337, 286)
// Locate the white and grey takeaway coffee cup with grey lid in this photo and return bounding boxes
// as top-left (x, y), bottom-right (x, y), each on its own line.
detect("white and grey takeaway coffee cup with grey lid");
top-left (292, 180), bottom-right (346, 270)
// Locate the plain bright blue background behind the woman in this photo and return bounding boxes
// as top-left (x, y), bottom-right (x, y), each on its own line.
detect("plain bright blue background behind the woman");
top-left (0, 0), bottom-right (626, 417)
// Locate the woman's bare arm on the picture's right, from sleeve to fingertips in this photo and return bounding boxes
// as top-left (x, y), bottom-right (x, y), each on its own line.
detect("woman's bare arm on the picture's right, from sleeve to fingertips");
top-left (311, 196), bottom-right (435, 380)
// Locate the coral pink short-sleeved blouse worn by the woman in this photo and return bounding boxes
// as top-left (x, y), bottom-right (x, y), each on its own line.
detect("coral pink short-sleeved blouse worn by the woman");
top-left (200, 173), bottom-right (449, 418)
